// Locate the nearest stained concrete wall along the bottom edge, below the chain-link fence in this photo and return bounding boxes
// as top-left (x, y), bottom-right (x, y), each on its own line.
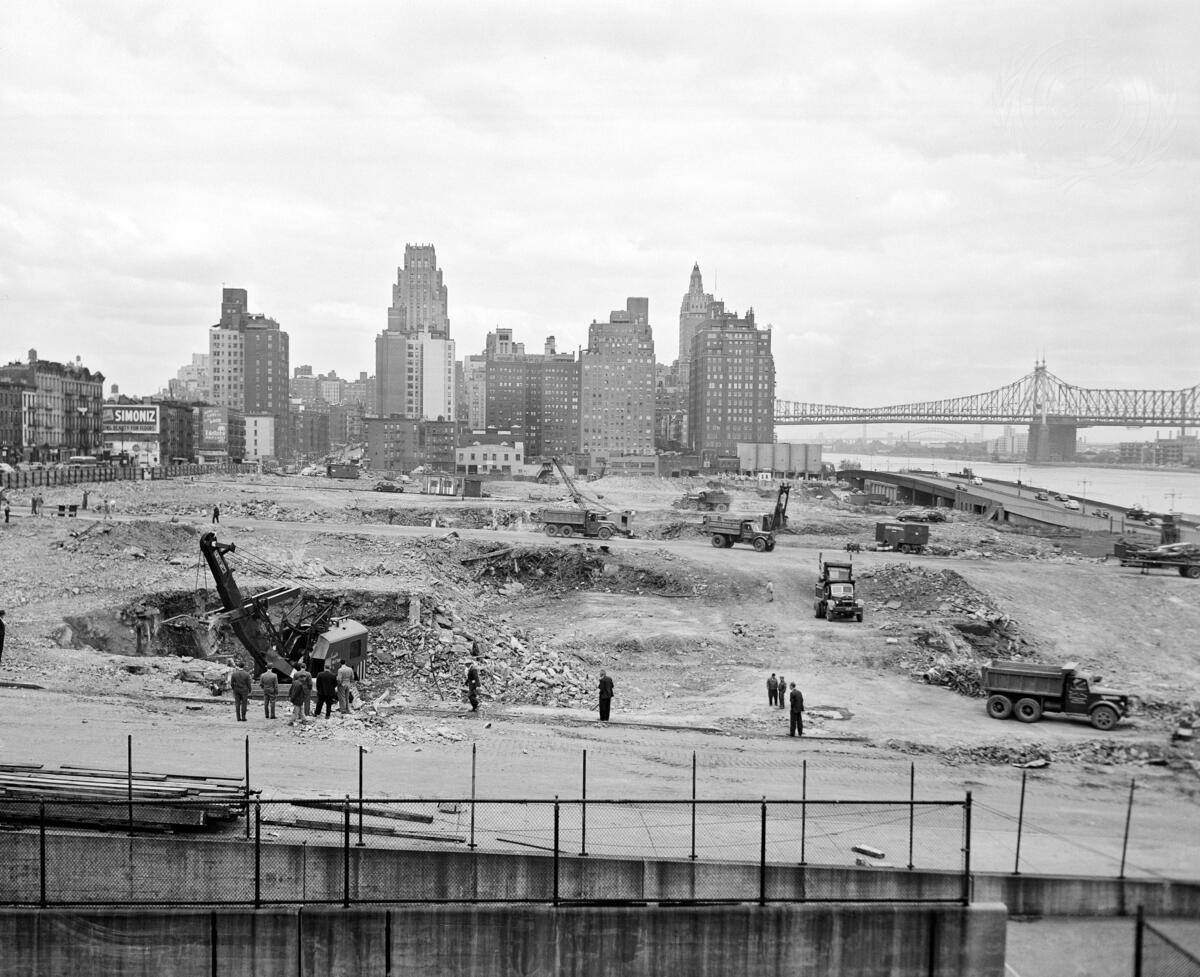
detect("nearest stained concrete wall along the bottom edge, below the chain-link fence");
top-left (0, 905), bottom-right (1006, 977)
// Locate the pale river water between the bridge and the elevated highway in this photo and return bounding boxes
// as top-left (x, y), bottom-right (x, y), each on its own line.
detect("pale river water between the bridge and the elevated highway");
top-left (822, 452), bottom-right (1200, 516)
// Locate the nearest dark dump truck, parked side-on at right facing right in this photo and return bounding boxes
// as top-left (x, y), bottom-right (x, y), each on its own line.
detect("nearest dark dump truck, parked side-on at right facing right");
top-left (980, 660), bottom-right (1138, 730)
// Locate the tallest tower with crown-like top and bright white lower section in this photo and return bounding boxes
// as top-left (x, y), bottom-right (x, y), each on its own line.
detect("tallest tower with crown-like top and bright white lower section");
top-left (376, 245), bottom-right (457, 421)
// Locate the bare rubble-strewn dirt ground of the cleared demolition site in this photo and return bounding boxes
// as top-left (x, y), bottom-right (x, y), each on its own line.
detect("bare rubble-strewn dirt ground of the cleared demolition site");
top-left (0, 476), bottom-right (1200, 879)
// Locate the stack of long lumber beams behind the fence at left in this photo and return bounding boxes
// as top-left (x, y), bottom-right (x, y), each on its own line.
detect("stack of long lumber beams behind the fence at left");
top-left (0, 763), bottom-right (248, 831)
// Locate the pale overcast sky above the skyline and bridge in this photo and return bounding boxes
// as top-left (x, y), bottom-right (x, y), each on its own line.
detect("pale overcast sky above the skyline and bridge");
top-left (0, 0), bottom-right (1200, 415)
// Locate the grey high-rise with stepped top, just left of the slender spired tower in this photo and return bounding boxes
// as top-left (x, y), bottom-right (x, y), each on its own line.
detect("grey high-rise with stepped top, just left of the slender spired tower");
top-left (580, 298), bottom-right (654, 456)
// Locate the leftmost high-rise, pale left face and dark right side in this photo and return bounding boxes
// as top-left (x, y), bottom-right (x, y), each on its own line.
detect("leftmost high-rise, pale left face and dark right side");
top-left (209, 288), bottom-right (289, 416)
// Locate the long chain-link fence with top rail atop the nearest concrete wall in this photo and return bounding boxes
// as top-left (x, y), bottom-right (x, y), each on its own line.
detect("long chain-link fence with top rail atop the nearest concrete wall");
top-left (0, 795), bottom-right (971, 906)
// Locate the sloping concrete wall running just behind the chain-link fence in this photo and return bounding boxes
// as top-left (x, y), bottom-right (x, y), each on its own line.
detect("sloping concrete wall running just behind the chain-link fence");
top-left (0, 832), bottom-right (1200, 918)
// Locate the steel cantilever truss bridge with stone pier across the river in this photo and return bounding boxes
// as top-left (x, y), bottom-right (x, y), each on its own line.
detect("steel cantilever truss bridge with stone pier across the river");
top-left (775, 362), bottom-right (1200, 462)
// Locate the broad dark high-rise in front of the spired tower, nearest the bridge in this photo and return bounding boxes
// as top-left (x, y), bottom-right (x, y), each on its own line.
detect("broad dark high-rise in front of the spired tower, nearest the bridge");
top-left (688, 301), bottom-right (775, 464)
